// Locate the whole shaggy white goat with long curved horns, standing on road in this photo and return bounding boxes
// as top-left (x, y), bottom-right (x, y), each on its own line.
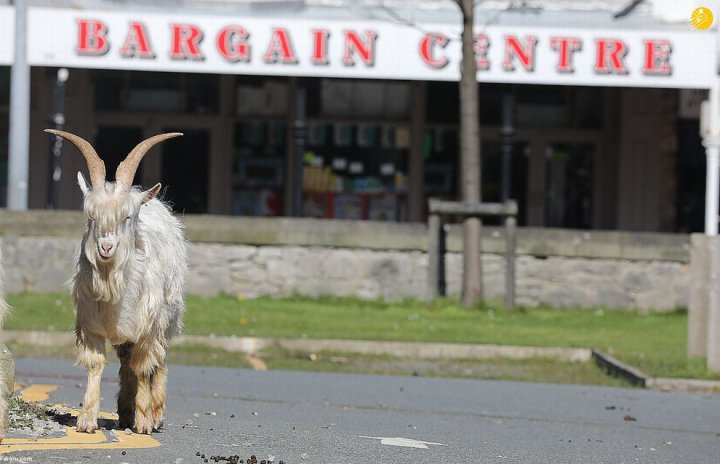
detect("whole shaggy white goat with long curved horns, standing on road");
top-left (45, 129), bottom-right (188, 434)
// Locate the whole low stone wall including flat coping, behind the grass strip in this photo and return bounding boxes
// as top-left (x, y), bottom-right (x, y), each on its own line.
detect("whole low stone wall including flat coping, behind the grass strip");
top-left (0, 210), bottom-right (690, 310)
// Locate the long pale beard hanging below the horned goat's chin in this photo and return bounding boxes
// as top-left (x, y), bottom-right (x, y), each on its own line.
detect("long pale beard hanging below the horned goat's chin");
top-left (85, 240), bottom-right (133, 303)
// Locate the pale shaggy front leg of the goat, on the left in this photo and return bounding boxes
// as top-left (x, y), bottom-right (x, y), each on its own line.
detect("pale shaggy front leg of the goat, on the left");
top-left (76, 333), bottom-right (107, 433)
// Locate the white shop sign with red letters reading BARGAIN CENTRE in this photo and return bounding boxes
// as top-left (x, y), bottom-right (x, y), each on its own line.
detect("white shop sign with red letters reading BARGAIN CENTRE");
top-left (19, 8), bottom-right (716, 88)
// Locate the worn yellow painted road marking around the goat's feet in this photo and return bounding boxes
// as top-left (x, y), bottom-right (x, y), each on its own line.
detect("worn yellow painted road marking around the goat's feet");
top-left (0, 384), bottom-right (160, 454)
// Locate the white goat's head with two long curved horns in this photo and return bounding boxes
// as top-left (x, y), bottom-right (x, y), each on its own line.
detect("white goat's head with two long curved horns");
top-left (45, 129), bottom-right (182, 263)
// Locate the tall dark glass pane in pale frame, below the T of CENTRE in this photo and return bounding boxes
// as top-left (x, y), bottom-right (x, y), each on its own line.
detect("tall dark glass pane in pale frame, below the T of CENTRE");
top-left (545, 143), bottom-right (594, 229)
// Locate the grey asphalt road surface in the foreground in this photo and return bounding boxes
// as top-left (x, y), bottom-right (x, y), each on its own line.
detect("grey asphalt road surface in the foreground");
top-left (5, 360), bottom-right (720, 464)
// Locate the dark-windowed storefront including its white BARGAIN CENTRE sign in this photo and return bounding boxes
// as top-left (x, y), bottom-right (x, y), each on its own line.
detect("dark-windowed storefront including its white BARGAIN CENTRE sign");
top-left (0, 1), bottom-right (715, 231)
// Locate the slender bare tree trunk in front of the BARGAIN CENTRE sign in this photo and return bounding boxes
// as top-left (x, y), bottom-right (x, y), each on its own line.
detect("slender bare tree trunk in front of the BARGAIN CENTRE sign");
top-left (456, 0), bottom-right (483, 308)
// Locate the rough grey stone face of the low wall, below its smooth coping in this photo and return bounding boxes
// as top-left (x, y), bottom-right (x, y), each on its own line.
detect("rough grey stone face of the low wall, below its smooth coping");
top-left (2, 236), bottom-right (689, 310)
